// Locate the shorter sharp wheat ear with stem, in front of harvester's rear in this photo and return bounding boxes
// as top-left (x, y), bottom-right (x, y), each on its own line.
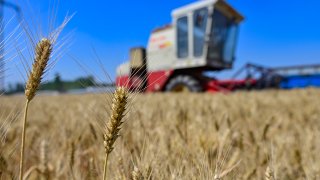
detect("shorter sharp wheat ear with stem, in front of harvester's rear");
top-left (103, 86), bottom-right (129, 180)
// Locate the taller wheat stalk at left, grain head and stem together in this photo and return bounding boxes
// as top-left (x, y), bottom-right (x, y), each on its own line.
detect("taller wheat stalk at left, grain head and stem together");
top-left (19, 38), bottom-right (52, 180)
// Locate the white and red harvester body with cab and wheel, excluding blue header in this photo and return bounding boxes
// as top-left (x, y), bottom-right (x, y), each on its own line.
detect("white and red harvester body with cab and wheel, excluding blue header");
top-left (116, 0), bottom-right (243, 92)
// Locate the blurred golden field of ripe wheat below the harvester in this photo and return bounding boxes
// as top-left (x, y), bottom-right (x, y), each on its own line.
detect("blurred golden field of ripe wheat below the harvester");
top-left (0, 89), bottom-right (320, 179)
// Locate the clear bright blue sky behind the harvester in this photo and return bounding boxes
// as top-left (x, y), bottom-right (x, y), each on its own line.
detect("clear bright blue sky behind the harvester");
top-left (1, 0), bottom-right (320, 83)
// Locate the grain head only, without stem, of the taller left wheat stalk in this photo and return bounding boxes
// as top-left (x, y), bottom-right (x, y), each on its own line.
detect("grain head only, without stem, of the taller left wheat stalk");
top-left (25, 38), bottom-right (52, 101)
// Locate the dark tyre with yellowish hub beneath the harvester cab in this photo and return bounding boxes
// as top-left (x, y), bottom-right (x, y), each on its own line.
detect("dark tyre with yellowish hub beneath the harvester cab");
top-left (165, 75), bottom-right (202, 92)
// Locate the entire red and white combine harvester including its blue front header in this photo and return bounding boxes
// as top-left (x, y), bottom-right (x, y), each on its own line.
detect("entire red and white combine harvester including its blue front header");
top-left (116, 0), bottom-right (320, 92)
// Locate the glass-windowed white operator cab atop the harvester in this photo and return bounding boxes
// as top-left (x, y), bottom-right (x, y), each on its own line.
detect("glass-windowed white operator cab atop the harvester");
top-left (172, 0), bottom-right (243, 70)
